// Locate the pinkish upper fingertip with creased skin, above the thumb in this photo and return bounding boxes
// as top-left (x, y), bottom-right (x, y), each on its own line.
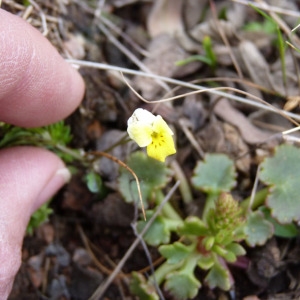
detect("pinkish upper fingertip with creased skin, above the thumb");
top-left (0, 9), bottom-right (84, 127)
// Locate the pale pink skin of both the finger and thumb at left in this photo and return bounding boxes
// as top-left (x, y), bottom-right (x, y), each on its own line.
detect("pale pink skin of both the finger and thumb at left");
top-left (0, 9), bottom-right (84, 300)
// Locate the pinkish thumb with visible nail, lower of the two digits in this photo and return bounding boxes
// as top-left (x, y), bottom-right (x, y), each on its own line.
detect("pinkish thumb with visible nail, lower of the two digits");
top-left (0, 147), bottom-right (69, 299)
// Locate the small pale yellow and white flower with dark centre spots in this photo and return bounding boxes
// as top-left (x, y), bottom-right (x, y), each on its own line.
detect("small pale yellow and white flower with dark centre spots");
top-left (127, 108), bottom-right (176, 162)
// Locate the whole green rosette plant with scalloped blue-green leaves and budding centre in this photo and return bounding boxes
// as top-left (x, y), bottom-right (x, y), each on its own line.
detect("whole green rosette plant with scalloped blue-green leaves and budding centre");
top-left (119, 145), bottom-right (300, 300)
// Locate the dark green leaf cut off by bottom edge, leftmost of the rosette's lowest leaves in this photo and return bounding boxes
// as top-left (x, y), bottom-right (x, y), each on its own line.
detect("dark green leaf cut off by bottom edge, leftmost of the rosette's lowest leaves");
top-left (129, 272), bottom-right (159, 300)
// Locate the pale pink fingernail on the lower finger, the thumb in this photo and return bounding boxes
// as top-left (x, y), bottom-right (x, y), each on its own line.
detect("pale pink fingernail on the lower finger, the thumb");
top-left (32, 167), bottom-right (71, 212)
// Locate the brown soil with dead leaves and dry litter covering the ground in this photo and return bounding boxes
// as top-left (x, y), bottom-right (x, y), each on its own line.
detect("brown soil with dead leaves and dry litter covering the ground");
top-left (2, 0), bottom-right (300, 300)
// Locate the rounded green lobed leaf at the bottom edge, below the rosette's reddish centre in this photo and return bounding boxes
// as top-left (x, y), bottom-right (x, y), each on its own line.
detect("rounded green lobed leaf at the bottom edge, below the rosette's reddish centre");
top-left (164, 271), bottom-right (201, 300)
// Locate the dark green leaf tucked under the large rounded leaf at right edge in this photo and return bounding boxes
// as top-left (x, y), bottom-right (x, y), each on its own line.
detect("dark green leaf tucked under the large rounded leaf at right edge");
top-left (259, 206), bottom-right (299, 238)
